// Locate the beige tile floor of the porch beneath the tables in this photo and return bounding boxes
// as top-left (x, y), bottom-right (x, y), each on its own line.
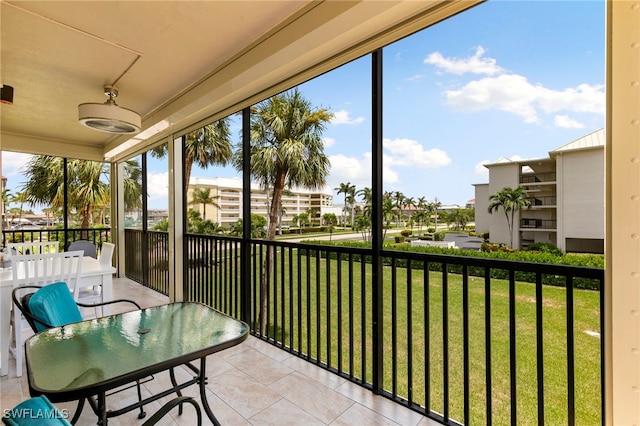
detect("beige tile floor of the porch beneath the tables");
top-left (0, 279), bottom-right (438, 426)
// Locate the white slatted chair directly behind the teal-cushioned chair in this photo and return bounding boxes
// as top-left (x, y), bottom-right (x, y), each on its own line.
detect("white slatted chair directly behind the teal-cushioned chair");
top-left (9, 251), bottom-right (84, 377)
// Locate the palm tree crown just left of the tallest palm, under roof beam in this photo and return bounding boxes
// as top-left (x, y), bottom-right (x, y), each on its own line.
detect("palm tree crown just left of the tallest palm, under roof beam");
top-left (151, 118), bottom-right (232, 192)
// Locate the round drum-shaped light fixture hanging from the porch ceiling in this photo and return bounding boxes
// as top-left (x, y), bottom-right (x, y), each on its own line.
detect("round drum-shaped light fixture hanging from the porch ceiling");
top-left (78, 86), bottom-right (142, 134)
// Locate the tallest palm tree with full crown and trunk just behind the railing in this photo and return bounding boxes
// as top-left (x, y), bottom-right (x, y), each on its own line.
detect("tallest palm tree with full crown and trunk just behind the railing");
top-left (233, 89), bottom-right (333, 333)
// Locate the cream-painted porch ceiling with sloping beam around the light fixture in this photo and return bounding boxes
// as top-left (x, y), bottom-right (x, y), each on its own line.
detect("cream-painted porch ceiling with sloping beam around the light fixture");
top-left (0, 0), bottom-right (477, 160)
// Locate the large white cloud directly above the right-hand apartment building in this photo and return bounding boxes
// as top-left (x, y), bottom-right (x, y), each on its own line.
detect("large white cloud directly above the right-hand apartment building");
top-left (444, 74), bottom-right (605, 123)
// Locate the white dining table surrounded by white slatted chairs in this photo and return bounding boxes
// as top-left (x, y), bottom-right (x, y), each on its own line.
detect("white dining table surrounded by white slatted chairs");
top-left (0, 256), bottom-right (116, 376)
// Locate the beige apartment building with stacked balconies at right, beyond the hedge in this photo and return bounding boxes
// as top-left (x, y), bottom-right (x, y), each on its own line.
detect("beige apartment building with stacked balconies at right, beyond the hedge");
top-left (474, 129), bottom-right (605, 253)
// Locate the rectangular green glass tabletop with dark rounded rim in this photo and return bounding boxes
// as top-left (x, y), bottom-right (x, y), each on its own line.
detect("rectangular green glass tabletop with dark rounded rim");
top-left (25, 302), bottom-right (249, 416)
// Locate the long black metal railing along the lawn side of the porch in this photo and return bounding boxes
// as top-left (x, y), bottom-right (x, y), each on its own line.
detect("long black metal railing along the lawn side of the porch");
top-left (127, 234), bottom-right (604, 425)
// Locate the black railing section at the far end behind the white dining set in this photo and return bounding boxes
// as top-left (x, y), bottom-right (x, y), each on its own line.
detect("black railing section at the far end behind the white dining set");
top-left (2, 228), bottom-right (111, 250)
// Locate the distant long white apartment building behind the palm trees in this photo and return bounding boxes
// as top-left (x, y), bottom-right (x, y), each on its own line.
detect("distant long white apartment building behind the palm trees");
top-left (187, 177), bottom-right (333, 227)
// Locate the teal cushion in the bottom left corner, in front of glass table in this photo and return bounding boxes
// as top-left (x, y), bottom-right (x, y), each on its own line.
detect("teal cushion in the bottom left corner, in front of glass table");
top-left (2, 394), bottom-right (71, 426)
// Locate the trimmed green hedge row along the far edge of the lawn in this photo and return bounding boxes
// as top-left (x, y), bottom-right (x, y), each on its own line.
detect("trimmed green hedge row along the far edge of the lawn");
top-left (300, 241), bottom-right (605, 290)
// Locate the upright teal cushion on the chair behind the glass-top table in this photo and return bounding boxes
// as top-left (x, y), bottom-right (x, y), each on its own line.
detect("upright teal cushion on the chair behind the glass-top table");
top-left (28, 282), bottom-right (82, 331)
